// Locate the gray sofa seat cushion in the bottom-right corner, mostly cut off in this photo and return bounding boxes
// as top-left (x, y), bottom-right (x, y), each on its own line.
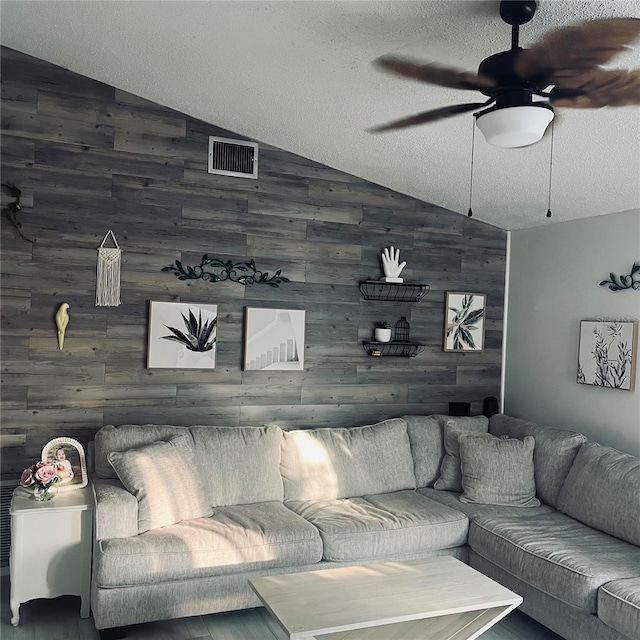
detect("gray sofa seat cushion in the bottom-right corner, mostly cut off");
top-left (598, 577), bottom-right (640, 640)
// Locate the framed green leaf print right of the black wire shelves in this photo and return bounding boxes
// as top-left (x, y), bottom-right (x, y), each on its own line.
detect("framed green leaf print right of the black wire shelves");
top-left (444, 291), bottom-right (486, 352)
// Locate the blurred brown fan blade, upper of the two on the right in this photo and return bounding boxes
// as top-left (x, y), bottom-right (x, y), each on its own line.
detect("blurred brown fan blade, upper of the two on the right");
top-left (515, 18), bottom-right (640, 84)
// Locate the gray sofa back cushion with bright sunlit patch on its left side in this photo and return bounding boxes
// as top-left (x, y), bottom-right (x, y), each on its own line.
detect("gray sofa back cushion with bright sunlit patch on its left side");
top-left (280, 418), bottom-right (416, 500)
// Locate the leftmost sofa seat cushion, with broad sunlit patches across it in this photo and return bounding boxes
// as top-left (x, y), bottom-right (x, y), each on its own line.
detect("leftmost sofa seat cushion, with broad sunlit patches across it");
top-left (96, 501), bottom-right (322, 588)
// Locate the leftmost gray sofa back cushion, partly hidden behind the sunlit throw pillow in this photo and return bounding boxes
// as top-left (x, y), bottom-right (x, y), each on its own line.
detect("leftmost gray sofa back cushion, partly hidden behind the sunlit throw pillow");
top-left (95, 424), bottom-right (191, 478)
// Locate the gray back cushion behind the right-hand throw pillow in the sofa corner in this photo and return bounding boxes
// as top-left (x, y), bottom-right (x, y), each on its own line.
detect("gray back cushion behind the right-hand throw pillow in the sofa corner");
top-left (489, 414), bottom-right (587, 508)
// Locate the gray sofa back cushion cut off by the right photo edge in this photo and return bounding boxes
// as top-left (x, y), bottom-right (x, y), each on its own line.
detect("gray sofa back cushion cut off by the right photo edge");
top-left (558, 443), bottom-right (640, 546)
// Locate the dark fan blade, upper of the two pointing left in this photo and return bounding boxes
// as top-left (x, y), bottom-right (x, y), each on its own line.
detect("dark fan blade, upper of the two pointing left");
top-left (374, 56), bottom-right (496, 91)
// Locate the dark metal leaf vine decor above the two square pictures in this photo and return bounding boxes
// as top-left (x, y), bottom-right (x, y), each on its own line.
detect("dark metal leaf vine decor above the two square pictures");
top-left (162, 253), bottom-right (290, 288)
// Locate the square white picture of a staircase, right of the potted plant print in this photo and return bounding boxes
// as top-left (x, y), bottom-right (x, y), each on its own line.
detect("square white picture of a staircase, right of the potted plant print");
top-left (244, 307), bottom-right (305, 371)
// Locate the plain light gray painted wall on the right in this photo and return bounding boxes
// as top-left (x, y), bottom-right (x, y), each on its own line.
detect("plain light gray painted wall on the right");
top-left (505, 210), bottom-right (640, 455)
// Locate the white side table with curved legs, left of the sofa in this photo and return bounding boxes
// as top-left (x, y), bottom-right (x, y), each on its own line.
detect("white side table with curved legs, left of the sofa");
top-left (9, 486), bottom-right (93, 627)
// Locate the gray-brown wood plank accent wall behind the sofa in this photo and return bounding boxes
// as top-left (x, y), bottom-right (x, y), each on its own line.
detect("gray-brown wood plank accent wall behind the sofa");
top-left (1, 48), bottom-right (506, 476)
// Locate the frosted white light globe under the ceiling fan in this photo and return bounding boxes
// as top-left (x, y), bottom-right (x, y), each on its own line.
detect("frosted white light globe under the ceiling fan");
top-left (476, 104), bottom-right (554, 149)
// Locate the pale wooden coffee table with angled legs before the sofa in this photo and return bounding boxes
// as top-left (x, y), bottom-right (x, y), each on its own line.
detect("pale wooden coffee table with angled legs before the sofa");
top-left (249, 556), bottom-right (522, 640)
